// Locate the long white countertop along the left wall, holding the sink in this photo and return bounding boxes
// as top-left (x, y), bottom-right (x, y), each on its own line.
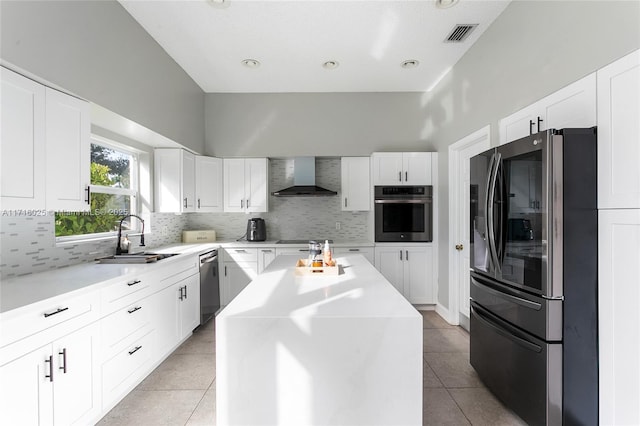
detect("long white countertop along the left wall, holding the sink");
top-left (0, 244), bottom-right (219, 313)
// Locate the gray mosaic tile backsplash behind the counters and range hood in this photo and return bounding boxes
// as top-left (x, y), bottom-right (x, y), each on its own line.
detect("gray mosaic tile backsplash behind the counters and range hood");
top-left (0, 158), bottom-right (373, 279)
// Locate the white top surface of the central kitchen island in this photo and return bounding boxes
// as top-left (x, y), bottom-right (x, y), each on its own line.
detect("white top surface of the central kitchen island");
top-left (218, 254), bottom-right (420, 319)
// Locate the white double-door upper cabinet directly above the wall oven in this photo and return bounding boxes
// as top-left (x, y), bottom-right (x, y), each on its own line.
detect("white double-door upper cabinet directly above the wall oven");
top-left (371, 152), bottom-right (432, 185)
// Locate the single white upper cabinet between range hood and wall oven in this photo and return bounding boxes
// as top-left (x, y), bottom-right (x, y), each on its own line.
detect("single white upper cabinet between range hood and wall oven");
top-left (341, 157), bottom-right (371, 211)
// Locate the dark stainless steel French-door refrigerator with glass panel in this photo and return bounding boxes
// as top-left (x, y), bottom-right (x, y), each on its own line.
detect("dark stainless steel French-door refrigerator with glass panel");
top-left (470, 128), bottom-right (598, 425)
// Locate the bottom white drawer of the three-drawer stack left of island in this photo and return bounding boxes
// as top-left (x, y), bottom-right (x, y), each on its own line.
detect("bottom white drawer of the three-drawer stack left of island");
top-left (102, 328), bottom-right (155, 410)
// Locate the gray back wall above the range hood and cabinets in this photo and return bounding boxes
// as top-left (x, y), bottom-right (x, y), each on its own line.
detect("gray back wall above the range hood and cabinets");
top-left (205, 93), bottom-right (434, 157)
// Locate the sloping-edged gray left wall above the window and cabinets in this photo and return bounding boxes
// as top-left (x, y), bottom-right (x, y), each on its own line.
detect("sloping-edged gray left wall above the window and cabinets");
top-left (0, 0), bottom-right (205, 152)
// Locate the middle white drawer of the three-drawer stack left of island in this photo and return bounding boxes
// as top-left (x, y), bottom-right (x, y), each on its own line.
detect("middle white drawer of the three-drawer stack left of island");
top-left (101, 298), bottom-right (151, 356)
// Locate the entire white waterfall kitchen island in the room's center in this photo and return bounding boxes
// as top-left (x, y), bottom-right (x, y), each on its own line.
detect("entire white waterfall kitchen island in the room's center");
top-left (216, 255), bottom-right (423, 425)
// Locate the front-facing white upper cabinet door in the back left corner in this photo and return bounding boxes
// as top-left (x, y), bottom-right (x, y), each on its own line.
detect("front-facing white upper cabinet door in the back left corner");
top-left (196, 155), bottom-right (223, 213)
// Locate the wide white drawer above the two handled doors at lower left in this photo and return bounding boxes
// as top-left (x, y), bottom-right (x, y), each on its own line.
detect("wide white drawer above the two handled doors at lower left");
top-left (0, 291), bottom-right (100, 347)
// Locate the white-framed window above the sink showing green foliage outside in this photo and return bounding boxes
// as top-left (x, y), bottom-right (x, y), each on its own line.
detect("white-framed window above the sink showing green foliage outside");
top-left (55, 136), bottom-right (140, 241)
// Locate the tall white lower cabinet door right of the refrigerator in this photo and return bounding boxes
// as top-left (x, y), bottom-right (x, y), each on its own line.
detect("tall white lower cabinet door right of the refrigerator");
top-left (598, 209), bottom-right (640, 425)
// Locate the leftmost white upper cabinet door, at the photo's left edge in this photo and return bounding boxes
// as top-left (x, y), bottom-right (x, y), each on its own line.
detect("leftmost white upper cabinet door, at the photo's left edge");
top-left (0, 67), bottom-right (46, 210)
